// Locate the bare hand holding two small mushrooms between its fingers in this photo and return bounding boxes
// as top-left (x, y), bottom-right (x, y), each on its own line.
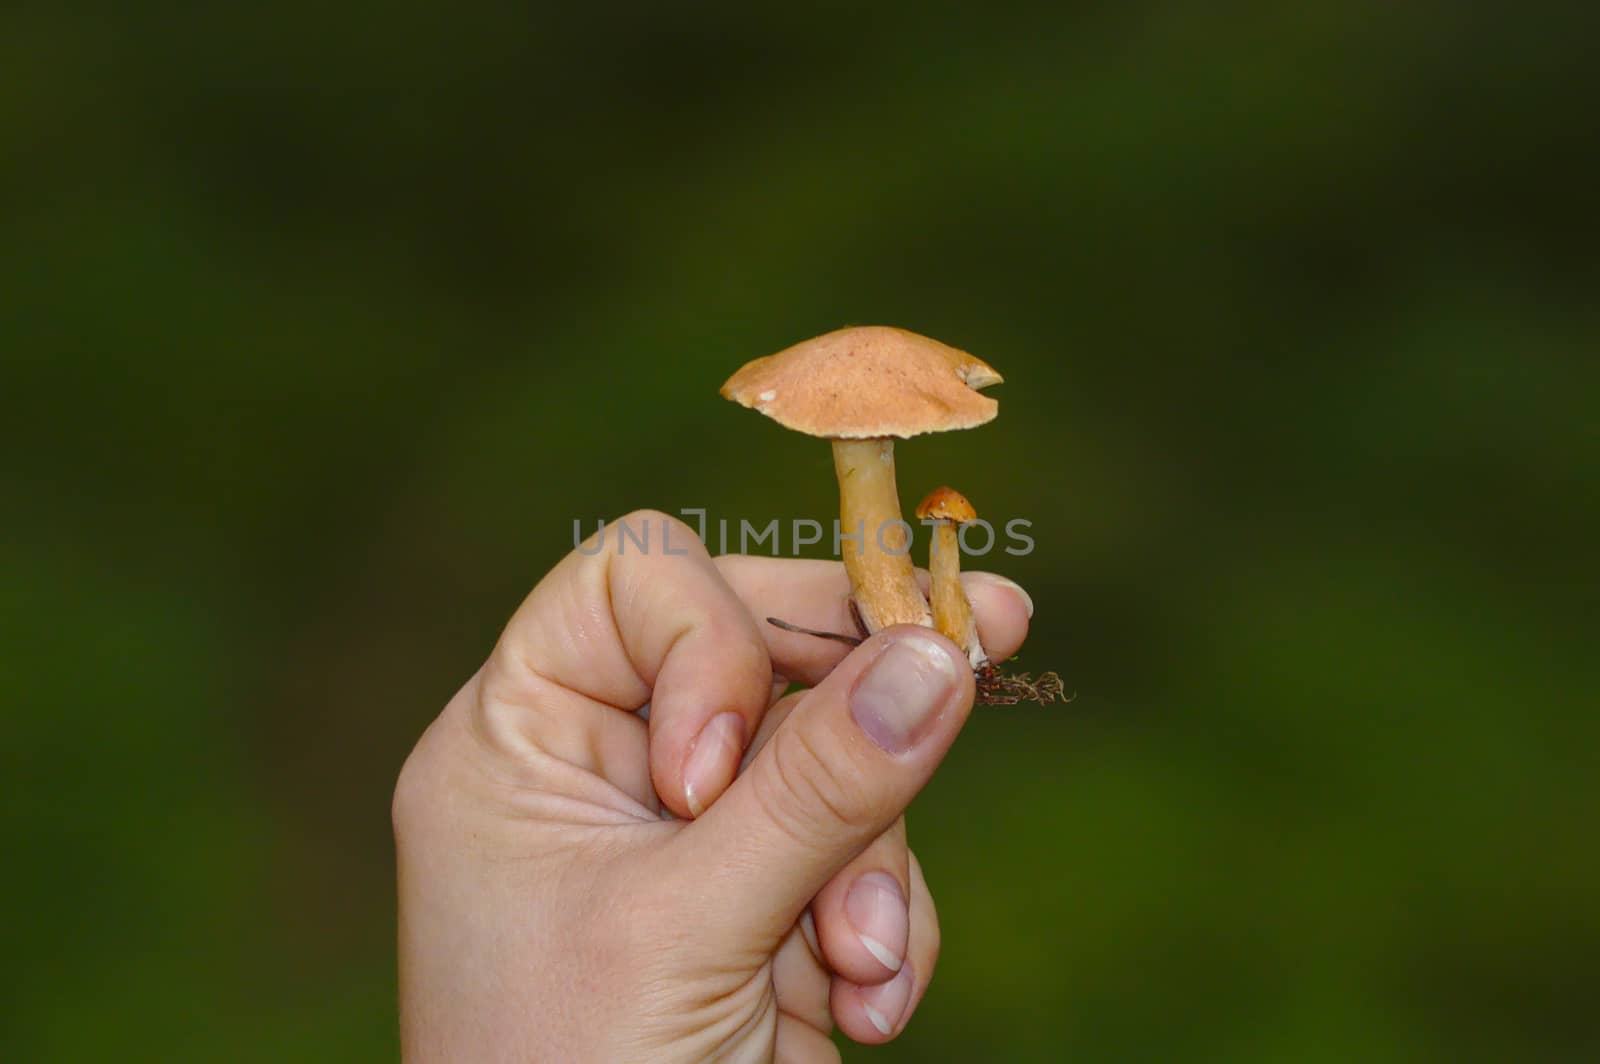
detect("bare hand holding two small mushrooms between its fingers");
top-left (394, 512), bottom-right (1029, 1062)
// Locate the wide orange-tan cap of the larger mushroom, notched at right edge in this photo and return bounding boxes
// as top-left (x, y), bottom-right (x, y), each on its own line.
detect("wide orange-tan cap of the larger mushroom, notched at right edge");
top-left (722, 325), bottom-right (1002, 440)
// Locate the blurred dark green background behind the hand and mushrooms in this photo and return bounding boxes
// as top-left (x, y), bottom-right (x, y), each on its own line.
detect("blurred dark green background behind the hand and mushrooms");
top-left (0, 0), bottom-right (1600, 1062)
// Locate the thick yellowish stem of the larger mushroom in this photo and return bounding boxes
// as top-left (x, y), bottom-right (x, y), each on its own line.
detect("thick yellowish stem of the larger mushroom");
top-left (834, 438), bottom-right (933, 634)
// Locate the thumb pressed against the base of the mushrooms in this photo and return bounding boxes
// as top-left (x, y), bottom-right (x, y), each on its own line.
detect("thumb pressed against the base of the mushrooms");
top-left (674, 626), bottom-right (973, 942)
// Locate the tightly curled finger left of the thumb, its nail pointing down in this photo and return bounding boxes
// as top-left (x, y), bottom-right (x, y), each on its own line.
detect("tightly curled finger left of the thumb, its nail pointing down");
top-left (483, 510), bottom-right (771, 816)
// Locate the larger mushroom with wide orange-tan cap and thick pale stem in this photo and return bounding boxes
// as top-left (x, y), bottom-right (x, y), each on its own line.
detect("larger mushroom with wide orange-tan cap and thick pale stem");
top-left (722, 325), bottom-right (1002, 635)
